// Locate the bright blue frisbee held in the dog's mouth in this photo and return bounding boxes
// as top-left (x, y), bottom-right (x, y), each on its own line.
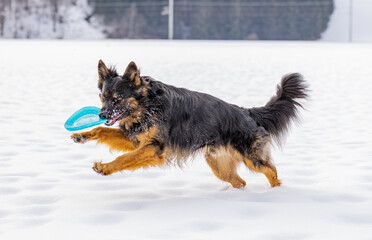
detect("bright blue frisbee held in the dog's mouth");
top-left (65, 106), bottom-right (107, 131)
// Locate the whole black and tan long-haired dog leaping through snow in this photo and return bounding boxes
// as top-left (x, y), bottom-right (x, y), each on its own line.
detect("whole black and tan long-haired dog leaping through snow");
top-left (71, 60), bottom-right (308, 188)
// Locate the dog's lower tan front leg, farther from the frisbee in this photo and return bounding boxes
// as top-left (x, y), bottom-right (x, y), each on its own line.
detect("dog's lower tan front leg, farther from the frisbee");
top-left (93, 145), bottom-right (166, 175)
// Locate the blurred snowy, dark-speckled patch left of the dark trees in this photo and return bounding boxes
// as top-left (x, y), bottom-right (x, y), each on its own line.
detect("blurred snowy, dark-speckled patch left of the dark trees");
top-left (0, 0), bottom-right (105, 39)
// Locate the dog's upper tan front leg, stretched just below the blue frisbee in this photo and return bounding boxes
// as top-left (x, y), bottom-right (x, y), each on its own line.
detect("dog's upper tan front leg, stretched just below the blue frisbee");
top-left (71, 127), bottom-right (139, 152)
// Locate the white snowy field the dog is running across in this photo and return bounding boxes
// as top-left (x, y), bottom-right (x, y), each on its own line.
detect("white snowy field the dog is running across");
top-left (0, 41), bottom-right (372, 240)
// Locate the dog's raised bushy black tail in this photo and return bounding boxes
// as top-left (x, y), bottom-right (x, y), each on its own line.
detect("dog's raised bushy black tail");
top-left (247, 73), bottom-right (308, 147)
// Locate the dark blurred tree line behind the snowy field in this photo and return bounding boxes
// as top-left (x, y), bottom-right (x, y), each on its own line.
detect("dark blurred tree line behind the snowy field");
top-left (89, 0), bottom-right (334, 40)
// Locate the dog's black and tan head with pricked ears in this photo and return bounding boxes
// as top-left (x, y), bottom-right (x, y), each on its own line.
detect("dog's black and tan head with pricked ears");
top-left (98, 60), bottom-right (147, 126)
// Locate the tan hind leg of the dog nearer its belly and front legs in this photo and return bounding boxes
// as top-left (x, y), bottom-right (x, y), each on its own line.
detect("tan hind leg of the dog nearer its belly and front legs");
top-left (205, 148), bottom-right (246, 188)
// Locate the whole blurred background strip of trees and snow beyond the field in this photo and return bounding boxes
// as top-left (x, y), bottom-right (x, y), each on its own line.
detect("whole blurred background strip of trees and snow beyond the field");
top-left (0, 0), bottom-right (372, 42)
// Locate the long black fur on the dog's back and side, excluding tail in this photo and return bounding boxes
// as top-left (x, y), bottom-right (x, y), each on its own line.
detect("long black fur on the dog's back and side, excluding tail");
top-left (152, 81), bottom-right (263, 158)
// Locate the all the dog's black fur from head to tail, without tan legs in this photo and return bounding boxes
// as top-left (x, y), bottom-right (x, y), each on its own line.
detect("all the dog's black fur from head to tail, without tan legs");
top-left (100, 63), bottom-right (307, 162)
